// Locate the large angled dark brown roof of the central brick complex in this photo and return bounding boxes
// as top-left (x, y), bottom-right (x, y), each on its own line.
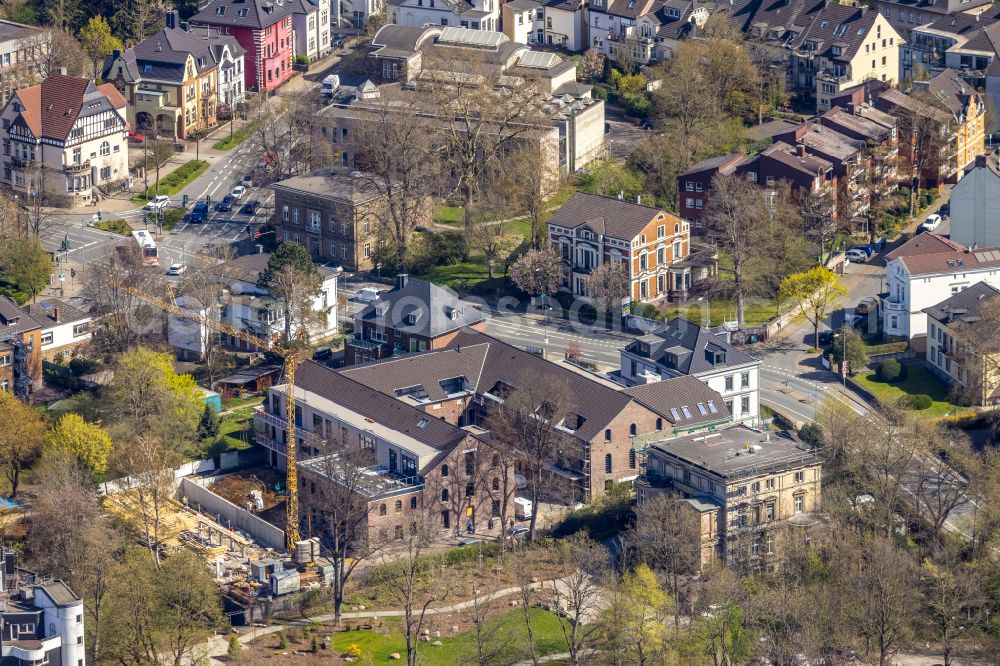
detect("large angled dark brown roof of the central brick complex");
top-left (341, 328), bottom-right (640, 441)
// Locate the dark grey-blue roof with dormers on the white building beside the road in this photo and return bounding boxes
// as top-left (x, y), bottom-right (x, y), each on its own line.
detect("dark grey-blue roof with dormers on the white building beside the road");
top-left (625, 317), bottom-right (758, 375)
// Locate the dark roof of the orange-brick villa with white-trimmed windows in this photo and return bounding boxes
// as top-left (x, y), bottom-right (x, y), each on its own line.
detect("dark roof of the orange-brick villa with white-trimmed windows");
top-left (549, 192), bottom-right (679, 241)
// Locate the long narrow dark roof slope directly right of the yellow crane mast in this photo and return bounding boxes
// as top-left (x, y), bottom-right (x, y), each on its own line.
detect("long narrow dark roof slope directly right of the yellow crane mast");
top-left (295, 361), bottom-right (469, 450)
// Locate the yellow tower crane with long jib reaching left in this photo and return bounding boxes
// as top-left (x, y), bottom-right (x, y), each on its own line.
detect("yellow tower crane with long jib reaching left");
top-left (117, 282), bottom-right (302, 552)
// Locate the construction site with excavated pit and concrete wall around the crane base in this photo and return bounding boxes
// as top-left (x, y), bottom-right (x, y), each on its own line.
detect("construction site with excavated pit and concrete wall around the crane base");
top-left (104, 467), bottom-right (334, 626)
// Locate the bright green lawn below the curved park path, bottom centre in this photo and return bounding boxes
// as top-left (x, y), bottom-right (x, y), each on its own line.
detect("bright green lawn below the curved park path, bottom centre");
top-left (332, 608), bottom-right (567, 666)
